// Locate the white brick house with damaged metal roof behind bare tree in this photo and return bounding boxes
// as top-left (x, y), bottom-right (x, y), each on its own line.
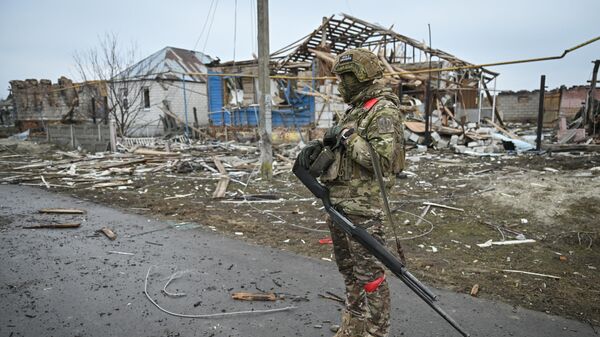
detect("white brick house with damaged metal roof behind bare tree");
top-left (109, 47), bottom-right (213, 136)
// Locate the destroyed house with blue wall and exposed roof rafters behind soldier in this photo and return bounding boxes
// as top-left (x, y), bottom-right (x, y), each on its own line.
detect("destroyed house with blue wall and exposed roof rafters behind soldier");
top-left (209, 14), bottom-right (498, 127)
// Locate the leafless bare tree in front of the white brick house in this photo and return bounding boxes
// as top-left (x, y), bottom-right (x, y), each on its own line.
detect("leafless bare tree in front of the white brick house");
top-left (73, 33), bottom-right (152, 136)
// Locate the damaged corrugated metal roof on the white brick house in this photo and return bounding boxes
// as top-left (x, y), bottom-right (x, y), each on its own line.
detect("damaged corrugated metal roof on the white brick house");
top-left (116, 47), bottom-right (213, 82)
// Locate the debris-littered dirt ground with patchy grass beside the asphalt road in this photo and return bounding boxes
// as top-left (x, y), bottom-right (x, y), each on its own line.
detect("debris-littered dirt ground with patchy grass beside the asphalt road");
top-left (3, 139), bottom-right (600, 326)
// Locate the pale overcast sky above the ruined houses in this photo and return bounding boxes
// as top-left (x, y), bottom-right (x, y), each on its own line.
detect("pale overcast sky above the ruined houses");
top-left (0, 0), bottom-right (600, 98)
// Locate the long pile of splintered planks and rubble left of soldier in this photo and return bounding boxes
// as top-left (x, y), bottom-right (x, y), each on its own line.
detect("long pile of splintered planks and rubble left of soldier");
top-left (0, 139), bottom-right (297, 194)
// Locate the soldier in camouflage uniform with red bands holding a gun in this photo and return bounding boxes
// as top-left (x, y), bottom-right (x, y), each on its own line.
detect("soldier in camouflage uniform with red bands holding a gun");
top-left (298, 49), bottom-right (404, 337)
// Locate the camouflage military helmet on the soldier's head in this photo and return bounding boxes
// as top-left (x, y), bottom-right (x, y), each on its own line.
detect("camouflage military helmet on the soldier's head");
top-left (332, 48), bottom-right (383, 82)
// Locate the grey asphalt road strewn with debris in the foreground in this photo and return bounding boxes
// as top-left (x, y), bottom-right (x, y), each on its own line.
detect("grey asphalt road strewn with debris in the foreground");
top-left (0, 185), bottom-right (597, 337)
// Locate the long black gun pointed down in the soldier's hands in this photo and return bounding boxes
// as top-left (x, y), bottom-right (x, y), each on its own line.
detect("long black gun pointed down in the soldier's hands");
top-left (292, 161), bottom-right (469, 337)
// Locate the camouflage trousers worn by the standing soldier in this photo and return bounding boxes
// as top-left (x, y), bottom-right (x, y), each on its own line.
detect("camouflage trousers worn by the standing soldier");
top-left (328, 215), bottom-right (390, 337)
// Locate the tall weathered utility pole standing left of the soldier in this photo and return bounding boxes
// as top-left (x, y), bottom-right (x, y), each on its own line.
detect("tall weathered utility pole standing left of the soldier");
top-left (256, 0), bottom-right (273, 180)
